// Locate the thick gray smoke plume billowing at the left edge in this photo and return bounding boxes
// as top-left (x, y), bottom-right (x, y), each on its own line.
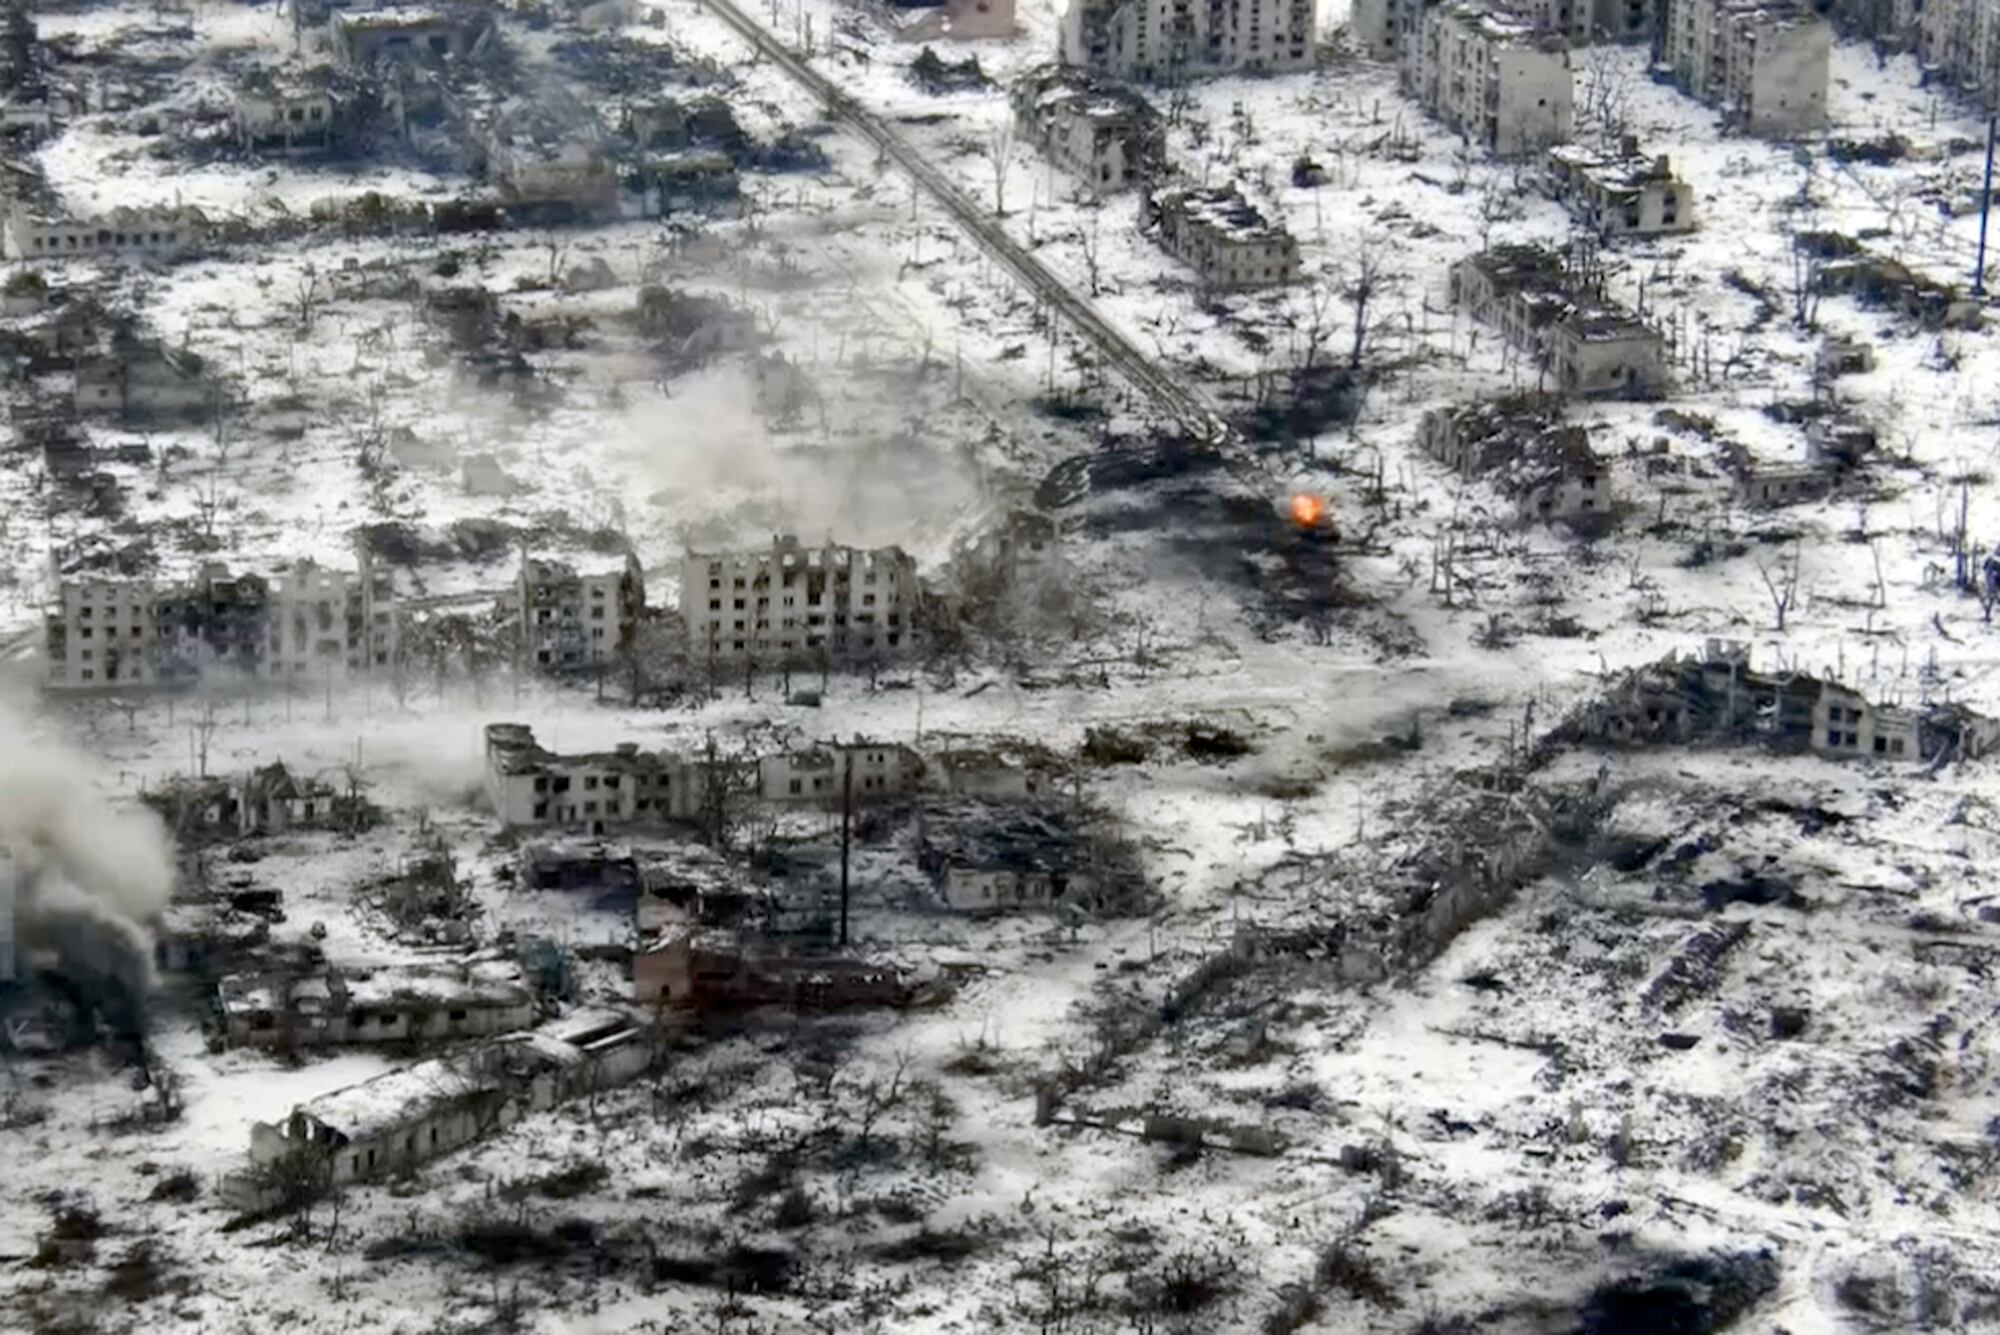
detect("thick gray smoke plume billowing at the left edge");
top-left (0, 701), bottom-right (174, 1031)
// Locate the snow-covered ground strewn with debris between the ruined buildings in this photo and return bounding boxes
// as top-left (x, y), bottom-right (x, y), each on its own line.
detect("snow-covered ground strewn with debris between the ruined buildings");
top-left (11, 0), bottom-right (2000, 1333)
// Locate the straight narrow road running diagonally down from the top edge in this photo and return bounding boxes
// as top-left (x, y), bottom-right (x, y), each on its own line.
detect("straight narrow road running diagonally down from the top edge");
top-left (702, 0), bottom-right (1236, 446)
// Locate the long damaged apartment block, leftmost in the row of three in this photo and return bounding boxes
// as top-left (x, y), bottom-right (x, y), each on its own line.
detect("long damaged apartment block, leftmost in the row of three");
top-left (46, 550), bottom-right (398, 691)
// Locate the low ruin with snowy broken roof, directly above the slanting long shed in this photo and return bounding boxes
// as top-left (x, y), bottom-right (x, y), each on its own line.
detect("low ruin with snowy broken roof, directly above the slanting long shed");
top-left (216, 963), bottom-right (538, 1049)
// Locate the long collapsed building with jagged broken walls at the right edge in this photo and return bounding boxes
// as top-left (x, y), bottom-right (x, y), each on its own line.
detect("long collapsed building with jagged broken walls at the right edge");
top-left (1558, 640), bottom-right (2000, 763)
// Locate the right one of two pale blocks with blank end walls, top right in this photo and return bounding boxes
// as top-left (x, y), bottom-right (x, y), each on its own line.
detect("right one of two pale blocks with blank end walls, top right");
top-left (1664, 0), bottom-right (1834, 138)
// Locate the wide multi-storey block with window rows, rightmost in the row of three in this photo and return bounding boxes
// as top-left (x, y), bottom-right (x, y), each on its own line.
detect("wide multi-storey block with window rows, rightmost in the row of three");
top-left (680, 534), bottom-right (920, 668)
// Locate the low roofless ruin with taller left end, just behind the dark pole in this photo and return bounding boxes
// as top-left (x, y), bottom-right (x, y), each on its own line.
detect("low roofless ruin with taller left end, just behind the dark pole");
top-left (486, 723), bottom-right (924, 835)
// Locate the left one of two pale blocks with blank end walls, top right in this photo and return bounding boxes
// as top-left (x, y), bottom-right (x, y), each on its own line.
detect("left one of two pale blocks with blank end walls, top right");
top-left (1402, 2), bottom-right (1574, 158)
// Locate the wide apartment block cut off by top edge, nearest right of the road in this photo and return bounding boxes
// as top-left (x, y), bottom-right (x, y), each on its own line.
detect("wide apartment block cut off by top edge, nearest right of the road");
top-left (1062, 0), bottom-right (1318, 80)
